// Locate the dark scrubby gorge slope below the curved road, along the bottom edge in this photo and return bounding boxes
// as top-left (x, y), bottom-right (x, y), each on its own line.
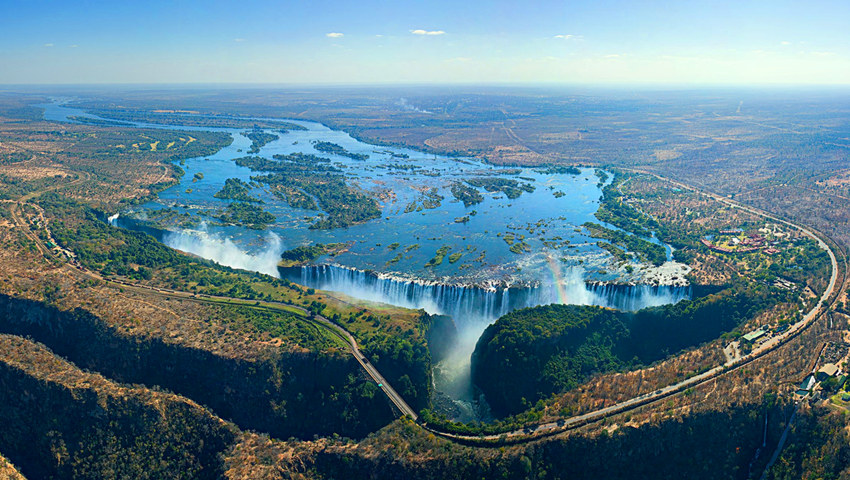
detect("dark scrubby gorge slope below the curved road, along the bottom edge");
top-left (264, 403), bottom-right (788, 480)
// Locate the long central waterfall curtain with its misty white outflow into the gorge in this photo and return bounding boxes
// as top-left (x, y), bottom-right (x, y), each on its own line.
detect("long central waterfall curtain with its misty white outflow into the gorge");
top-left (279, 265), bottom-right (692, 421)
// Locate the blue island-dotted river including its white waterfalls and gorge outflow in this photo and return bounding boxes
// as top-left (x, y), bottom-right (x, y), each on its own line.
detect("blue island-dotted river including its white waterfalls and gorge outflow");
top-left (41, 99), bottom-right (690, 420)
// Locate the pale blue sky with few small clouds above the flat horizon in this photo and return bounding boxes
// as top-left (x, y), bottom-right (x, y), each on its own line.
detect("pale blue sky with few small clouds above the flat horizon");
top-left (0, 0), bottom-right (850, 85)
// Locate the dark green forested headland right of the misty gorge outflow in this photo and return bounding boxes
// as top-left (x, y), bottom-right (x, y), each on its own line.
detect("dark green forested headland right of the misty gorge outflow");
top-left (472, 285), bottom-right (793, 415)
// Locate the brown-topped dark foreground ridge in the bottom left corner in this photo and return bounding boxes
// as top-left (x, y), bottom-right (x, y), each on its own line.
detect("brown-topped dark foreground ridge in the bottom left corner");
top-left (0, 335), bottom-right (236, 479)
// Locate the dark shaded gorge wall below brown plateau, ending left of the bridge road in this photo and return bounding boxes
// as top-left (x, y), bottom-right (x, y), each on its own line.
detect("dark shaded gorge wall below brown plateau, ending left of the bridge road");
top-left (0, 295), bottom-right (393, 438)
